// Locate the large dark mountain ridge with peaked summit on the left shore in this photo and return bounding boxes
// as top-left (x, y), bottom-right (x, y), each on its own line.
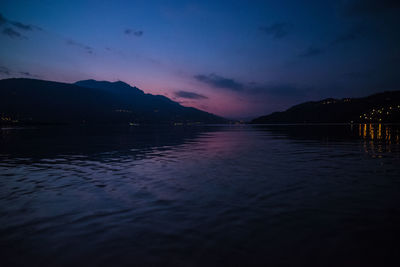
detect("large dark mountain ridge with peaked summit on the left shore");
top-left (0, 79), bottom-right (227, 124)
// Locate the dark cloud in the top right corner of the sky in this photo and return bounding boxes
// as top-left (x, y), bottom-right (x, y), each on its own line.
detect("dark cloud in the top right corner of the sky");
top-left (342, 0), bottom-right (400, 16)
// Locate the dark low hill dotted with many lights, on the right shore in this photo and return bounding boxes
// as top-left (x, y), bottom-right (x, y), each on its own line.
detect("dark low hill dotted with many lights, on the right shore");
top-left (251, 91), bottom-right (400, 124)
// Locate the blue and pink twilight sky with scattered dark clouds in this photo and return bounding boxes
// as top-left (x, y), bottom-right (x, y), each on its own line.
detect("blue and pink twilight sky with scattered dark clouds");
top-left (0, 0), bottom-right (400, 118)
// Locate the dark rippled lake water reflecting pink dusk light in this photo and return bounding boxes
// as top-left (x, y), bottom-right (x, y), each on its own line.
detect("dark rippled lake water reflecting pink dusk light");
top-left (0, 124), bottom-right (400, 266)
